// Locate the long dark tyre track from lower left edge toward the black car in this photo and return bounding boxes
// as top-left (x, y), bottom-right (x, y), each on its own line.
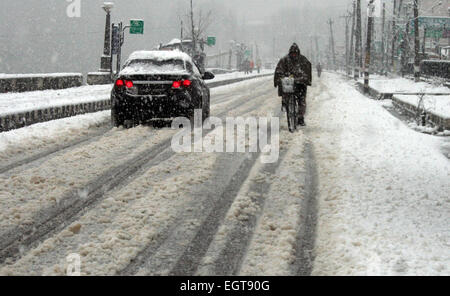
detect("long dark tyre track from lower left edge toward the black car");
top-left (0, 80), bottom-right (274, 264)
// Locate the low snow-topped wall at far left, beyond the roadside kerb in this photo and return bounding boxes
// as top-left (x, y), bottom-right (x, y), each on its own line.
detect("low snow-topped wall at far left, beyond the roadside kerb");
top-left (0, 73), bottom-right (83, 93)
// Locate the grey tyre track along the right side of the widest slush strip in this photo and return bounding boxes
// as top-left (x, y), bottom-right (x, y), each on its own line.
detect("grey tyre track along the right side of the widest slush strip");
top-left (118, 155), bottom-right (257, 275)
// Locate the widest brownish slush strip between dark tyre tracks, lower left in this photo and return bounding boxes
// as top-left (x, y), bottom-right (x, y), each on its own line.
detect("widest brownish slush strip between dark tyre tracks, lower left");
top-left (0, 79), bottom-right (279, 275)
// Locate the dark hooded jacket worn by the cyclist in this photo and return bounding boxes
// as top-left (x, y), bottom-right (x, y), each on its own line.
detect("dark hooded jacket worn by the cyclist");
top-left (274, 43), bottom-right (312, 87)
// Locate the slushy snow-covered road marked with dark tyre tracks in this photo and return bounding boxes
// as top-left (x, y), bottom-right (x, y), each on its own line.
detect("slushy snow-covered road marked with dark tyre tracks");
top-left (0, 73), bottom-right (450, 275)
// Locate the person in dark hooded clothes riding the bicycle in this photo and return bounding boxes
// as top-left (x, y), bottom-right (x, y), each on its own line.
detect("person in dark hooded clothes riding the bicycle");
top-left (274, 43), bottom-right (312, 126)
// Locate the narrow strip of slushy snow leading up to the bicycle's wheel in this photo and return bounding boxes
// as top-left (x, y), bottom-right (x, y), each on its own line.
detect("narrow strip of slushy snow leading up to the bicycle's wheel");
top-left (240, 76), bottom-right (323, 276)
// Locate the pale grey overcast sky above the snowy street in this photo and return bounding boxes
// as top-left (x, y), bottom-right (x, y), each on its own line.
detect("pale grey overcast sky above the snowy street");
top-left (0, 0), bottom-right (352, 73)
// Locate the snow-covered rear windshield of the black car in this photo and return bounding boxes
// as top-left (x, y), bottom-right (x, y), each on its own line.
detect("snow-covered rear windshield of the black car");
top-left (123, 59), bottom-right (186, 74)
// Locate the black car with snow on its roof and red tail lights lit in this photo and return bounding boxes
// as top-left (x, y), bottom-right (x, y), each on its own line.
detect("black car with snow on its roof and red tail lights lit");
top-left (111, 51), bottom-right (214, 127)
